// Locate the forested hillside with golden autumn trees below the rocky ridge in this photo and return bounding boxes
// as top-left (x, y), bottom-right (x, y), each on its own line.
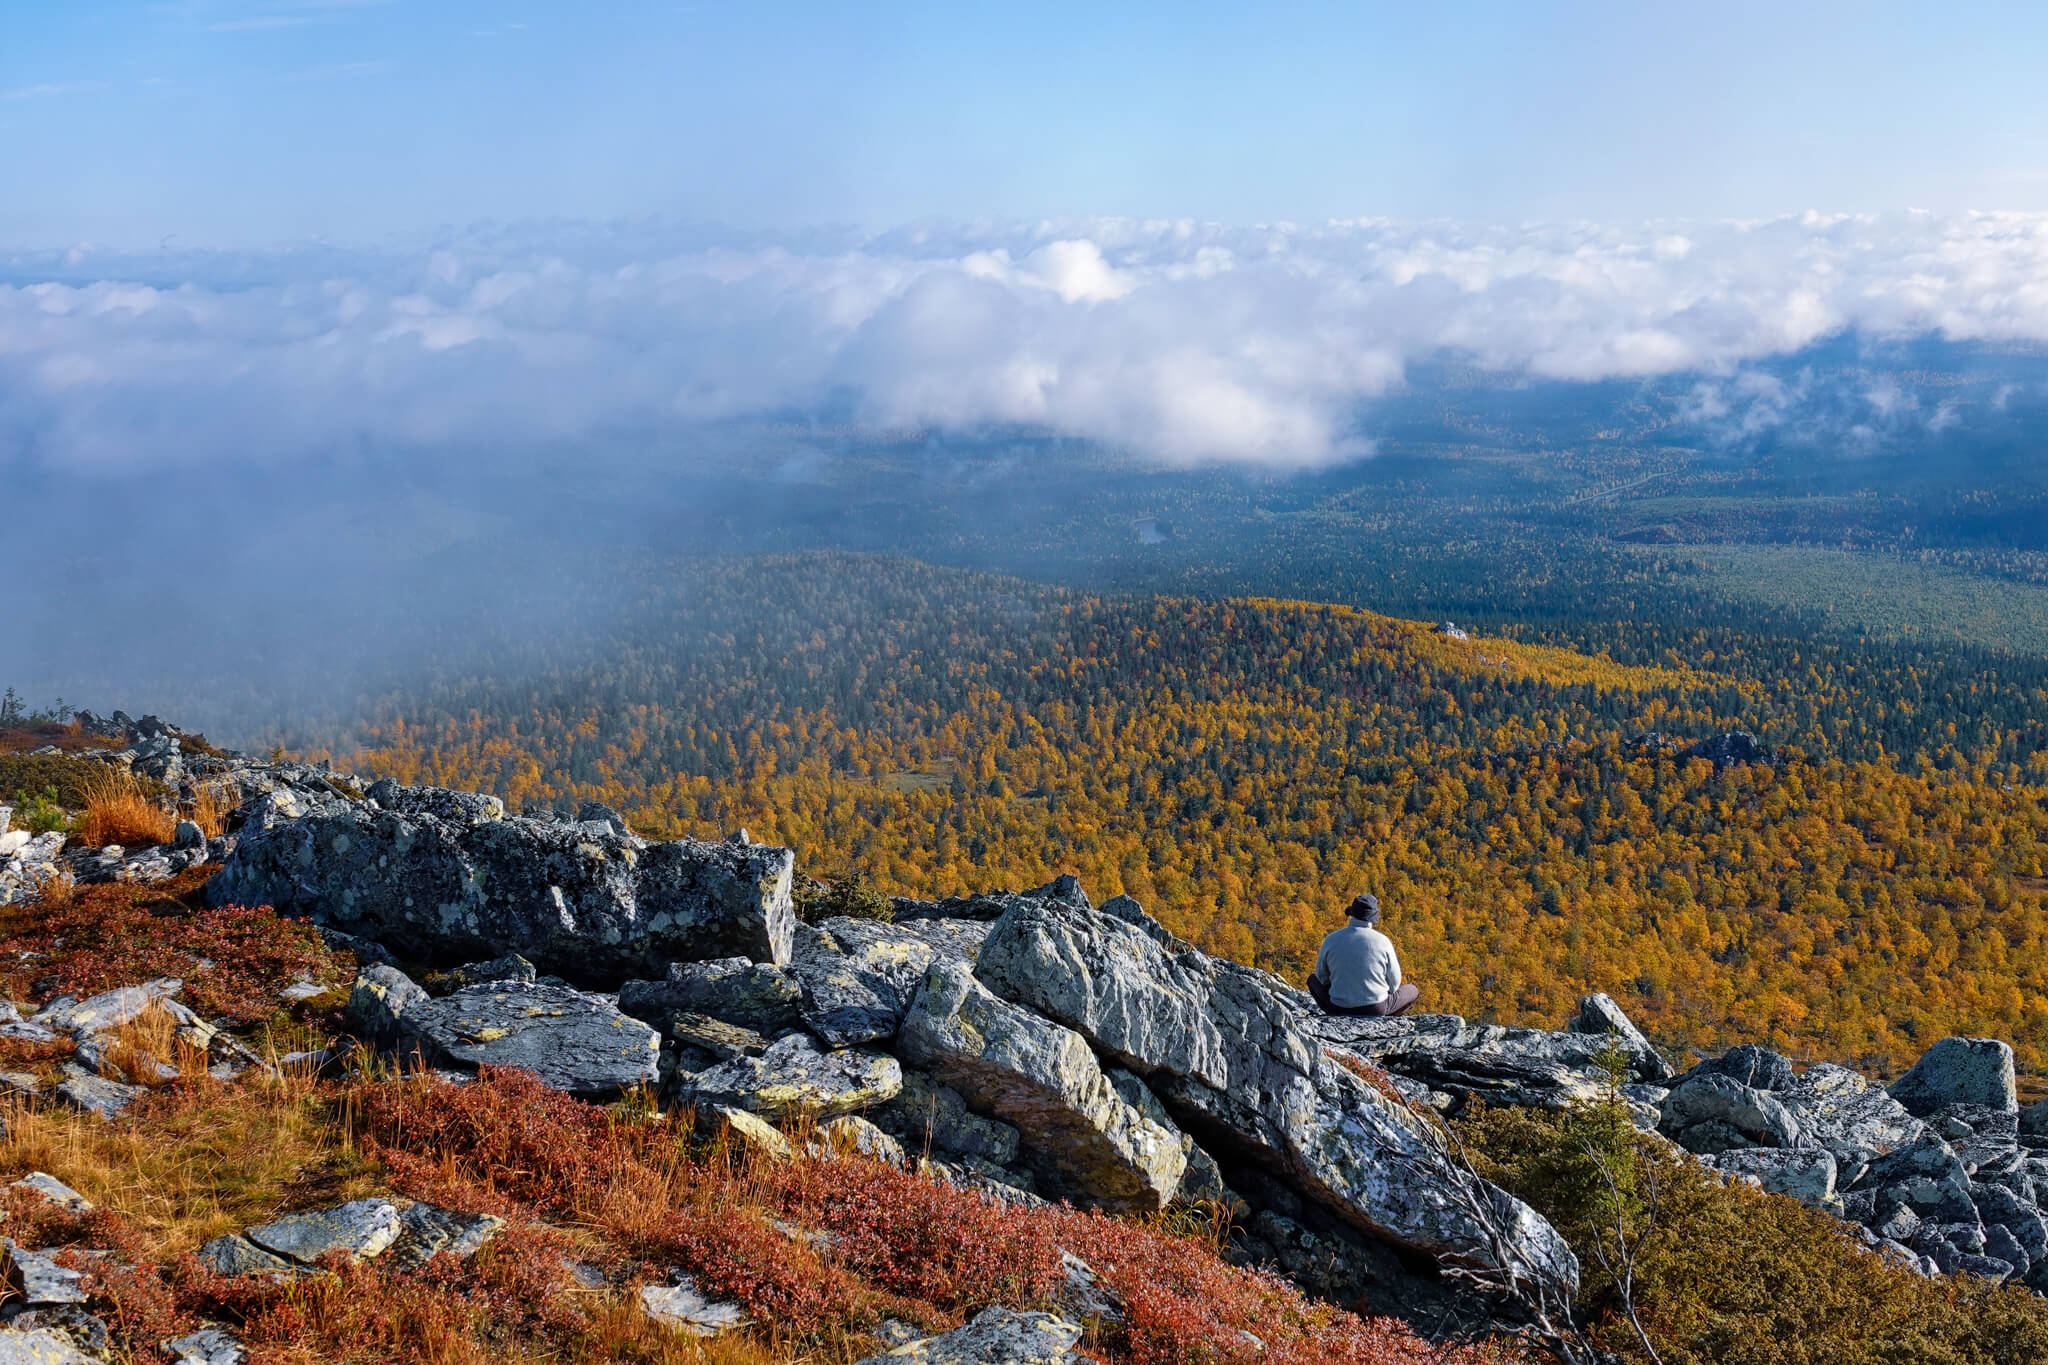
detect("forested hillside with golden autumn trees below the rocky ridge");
top-left (296, 555), bottom-right (2048, 1068)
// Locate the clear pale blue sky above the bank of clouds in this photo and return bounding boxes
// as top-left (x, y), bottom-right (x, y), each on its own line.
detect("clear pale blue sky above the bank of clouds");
top-left (12, 0), bottom-right (2048, 246)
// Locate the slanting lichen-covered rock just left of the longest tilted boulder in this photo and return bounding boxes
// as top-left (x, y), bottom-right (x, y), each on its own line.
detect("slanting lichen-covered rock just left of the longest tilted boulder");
top-left (897, 962), bottom-right (1186, 1209)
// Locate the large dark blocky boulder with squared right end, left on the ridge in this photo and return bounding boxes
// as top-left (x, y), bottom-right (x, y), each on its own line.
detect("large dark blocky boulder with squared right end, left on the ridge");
top-left (207, 784), bottom-right (797, 980)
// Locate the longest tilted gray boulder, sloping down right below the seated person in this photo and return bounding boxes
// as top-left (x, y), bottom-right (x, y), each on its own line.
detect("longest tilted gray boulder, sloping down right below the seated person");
top-left (975, 898), bottom-right (1579, 1293)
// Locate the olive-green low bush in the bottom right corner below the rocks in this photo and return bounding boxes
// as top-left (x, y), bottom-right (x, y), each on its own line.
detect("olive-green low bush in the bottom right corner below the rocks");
top-left (1460, 1105), bottom-right (2048, 1365)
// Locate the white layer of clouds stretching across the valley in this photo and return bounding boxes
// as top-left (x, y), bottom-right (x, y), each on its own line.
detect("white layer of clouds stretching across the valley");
top-left (0, 213), bottom-right (2048, 473)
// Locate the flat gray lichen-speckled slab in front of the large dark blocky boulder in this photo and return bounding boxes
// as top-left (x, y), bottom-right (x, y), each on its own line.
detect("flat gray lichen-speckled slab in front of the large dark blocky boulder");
top-left (397, 980), bottom-right (662, 1099)
